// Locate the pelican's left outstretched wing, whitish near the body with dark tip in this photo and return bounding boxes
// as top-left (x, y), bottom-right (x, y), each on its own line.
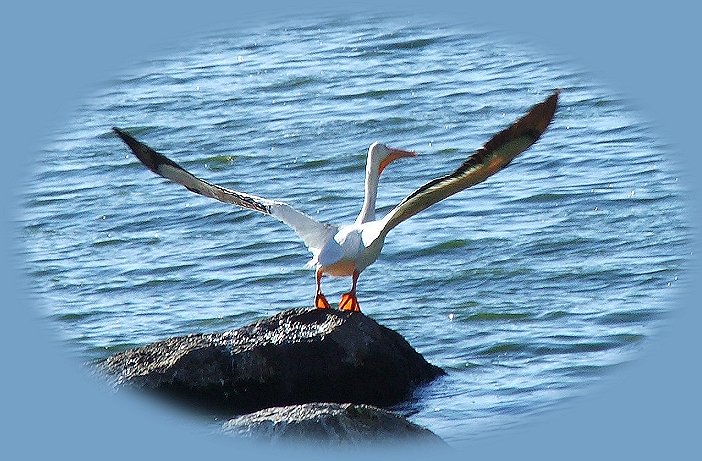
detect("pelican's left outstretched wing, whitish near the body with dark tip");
top-left (112, 128), bottom-right (337, 255)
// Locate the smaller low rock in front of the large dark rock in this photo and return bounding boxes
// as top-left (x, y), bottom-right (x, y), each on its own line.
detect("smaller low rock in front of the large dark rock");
top-left (222, 403), bottom-right (445, 446)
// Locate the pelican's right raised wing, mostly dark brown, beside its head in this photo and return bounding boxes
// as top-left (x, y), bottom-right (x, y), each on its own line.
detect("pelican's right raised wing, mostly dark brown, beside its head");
top-left (381, 91), bottom-right (559, 234)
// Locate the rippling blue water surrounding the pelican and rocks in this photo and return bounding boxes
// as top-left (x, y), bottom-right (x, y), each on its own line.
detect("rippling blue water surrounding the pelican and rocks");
top-left (20, 17), bottom-right (690, 443)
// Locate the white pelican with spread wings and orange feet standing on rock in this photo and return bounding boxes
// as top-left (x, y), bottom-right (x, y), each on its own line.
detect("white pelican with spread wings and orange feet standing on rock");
top-left (113, 90), bottom-right (559, 312)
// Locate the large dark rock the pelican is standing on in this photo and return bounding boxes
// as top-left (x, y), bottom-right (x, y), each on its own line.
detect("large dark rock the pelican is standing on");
top-left (98, 309), bottom-right (445, 415)
